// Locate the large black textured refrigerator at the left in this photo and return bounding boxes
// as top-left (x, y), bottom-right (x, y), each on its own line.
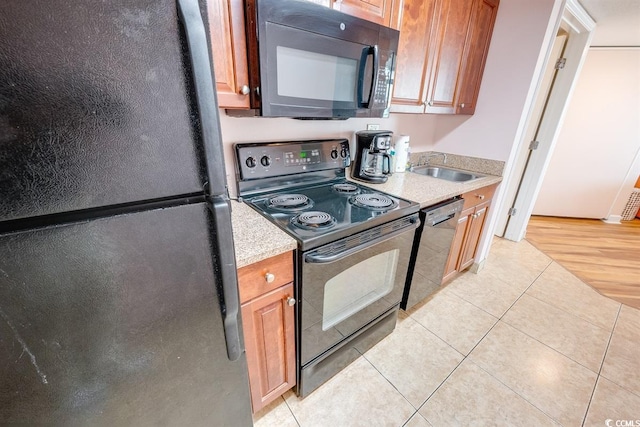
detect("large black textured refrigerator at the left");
top-left (0, 0), bottom-right (252, 427)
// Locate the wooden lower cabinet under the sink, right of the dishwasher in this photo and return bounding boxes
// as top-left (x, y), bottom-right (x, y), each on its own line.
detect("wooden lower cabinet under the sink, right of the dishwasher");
top-left (442, 184), bottom-right (498, 283)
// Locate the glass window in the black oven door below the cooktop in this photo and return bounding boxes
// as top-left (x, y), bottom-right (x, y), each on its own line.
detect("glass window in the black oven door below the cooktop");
top-left (322, 249), bottom-right (400, 331)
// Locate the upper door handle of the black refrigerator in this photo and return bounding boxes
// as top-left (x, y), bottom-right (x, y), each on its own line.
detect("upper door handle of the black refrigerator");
top-left (177, 0), bottom-right (227, 196)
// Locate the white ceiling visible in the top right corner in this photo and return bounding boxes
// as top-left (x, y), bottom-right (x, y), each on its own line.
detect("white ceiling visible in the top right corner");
top-left (578, 0), bottom-right (640, 47)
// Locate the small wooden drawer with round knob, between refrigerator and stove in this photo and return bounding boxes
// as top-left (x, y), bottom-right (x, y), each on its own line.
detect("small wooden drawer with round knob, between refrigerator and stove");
top-left (238, 252), bottom-right (293, 303)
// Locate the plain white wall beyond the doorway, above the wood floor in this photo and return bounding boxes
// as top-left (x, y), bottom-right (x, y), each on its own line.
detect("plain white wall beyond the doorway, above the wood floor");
top-left (533, 49), bottom-right (640, 218)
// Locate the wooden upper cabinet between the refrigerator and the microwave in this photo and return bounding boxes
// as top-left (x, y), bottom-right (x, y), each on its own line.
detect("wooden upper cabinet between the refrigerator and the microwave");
top-left (207, 0), bottom-right (250, 109)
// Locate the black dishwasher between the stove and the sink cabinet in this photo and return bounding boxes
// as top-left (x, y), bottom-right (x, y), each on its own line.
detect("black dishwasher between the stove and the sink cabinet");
top-left (400, 198), bottom-right (464, 310)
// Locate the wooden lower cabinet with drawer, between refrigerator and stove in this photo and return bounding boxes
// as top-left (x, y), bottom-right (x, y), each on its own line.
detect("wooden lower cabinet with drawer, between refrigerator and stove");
top-left (238, 252), bottom-right (296, 413)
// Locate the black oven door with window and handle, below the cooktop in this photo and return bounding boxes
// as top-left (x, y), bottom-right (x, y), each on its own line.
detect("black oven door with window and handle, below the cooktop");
top-left (300, 215), bottom-right (420, 365)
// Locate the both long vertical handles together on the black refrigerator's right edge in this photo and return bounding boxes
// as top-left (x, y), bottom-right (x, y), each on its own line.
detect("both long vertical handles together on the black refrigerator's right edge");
top-left (178, 0), bottom-right (244, 361)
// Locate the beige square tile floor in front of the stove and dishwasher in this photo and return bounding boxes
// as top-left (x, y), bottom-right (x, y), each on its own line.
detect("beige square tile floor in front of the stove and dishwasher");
top-left (254, 239), bottom-right (640, 427)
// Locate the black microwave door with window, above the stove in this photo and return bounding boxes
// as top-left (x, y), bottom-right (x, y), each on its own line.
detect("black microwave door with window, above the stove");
top-left (260, 22), bottom-right (374, 117)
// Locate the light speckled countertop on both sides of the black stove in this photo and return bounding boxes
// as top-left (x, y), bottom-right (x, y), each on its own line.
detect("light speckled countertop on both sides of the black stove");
top-left (231, 153), bottom-right (504, 268)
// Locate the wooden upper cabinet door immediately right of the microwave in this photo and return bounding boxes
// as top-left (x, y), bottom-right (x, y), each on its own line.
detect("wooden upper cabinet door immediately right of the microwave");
top-left (391, 0), bottom-right (442, 113)
